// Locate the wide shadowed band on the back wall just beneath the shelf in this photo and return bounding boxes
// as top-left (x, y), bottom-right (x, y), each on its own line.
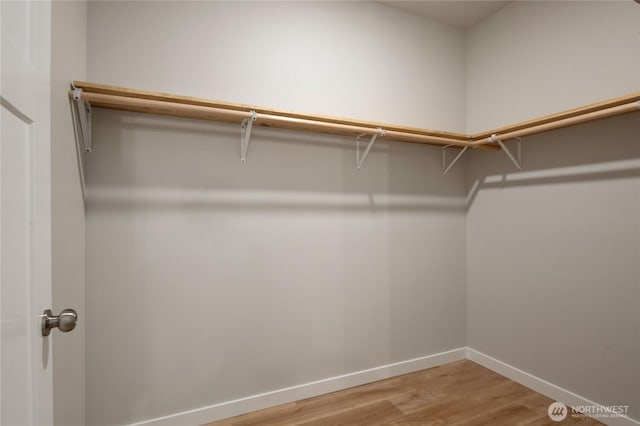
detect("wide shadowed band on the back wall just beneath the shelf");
top-left (87, 106), bottom-right (465, 212)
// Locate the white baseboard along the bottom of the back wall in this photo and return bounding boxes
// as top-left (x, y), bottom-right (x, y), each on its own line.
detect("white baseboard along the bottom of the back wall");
top-left (124, 348), bottom-right (467, 426)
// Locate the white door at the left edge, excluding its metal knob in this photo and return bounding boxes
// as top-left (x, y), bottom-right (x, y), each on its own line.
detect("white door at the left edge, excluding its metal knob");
top-left (0, 0), bottom-right (53, 426)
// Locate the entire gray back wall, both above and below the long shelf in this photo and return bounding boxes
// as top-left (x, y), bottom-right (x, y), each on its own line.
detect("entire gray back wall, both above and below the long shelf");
top-left (86, 2), bottom-right (465, 425)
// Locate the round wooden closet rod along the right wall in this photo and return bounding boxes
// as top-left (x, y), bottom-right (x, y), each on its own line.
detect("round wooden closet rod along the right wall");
top-left (473, 101), bottom-right (640, 146)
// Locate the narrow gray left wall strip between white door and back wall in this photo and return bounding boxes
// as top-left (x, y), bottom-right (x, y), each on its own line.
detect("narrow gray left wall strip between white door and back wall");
top-left (51, 1), bottom-right (87, 426)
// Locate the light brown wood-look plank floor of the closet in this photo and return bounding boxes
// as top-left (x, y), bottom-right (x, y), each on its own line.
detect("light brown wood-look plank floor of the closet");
top-left (207, 360), bottom-right (602, 426)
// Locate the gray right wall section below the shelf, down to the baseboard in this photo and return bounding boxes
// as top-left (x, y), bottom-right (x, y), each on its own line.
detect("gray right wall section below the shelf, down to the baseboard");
top-left (467, 114), bottom-right (640, 418)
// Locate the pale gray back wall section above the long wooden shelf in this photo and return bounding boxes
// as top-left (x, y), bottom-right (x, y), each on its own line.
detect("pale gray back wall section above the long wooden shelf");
top-left (88, 1), bottom-right (465, 131)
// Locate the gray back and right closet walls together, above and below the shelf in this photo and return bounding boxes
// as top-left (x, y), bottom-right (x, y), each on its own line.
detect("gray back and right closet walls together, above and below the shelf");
top-left (80, 1), bottom-right (640, 425)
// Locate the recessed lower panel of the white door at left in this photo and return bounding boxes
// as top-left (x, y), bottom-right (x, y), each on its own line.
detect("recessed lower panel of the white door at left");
top-left (0, 106), bottom-right (33, 425)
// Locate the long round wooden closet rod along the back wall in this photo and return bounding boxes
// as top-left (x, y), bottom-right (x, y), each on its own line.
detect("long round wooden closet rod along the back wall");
top-left (74, 91), bottom-right (473, 147)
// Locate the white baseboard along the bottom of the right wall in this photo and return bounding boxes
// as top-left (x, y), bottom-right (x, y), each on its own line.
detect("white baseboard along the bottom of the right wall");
top-left (467, 348), bottom-right (640, 426)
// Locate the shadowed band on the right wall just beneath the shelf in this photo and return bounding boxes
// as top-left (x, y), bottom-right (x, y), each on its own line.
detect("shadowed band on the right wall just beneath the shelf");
top-left (467, 113), bottom-right (640, 210)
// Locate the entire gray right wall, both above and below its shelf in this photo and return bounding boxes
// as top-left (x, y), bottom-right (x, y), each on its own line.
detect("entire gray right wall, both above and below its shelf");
top-left (466, 2), bottom-right (640, 419)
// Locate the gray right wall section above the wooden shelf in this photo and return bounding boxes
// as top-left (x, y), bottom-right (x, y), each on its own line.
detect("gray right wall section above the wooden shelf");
top-left (466, 1), bottom-right (640, 133)
